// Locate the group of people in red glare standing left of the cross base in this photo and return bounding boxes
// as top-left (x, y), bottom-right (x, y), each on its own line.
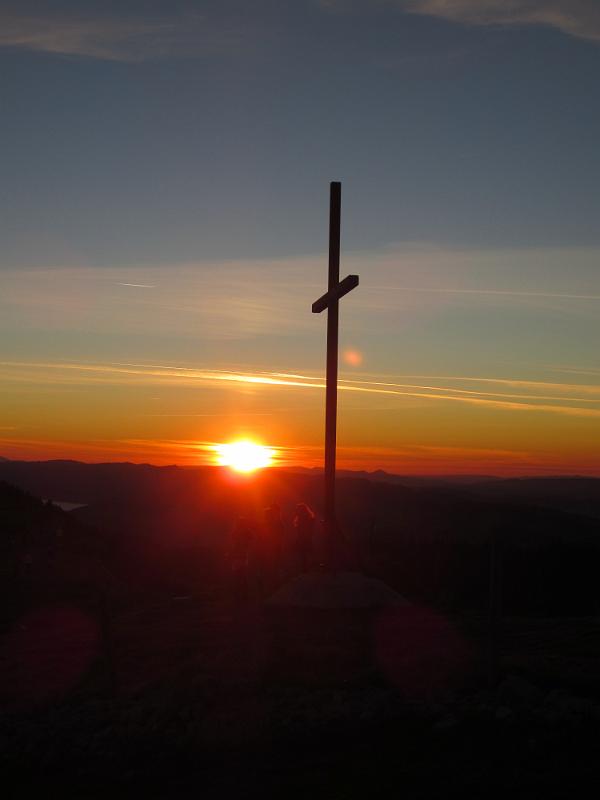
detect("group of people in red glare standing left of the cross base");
top-left (227, 503), bottom-right (318, 601)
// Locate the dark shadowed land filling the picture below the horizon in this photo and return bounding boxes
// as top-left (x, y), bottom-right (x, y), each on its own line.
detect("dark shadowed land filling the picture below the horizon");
top-left (0, 465), bottom-right (600, 798)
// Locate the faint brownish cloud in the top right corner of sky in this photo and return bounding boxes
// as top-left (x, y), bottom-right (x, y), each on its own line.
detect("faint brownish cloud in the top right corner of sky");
top-left (401, 0), bottom-right (600, 42)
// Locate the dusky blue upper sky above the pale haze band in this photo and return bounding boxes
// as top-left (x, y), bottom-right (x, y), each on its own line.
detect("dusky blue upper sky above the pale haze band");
top-left (0, 0), bottom-right (600, 266)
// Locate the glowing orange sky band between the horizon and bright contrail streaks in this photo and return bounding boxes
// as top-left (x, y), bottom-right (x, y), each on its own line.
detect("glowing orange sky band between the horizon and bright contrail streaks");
top-left (0, 361), bottom-right (600, 475)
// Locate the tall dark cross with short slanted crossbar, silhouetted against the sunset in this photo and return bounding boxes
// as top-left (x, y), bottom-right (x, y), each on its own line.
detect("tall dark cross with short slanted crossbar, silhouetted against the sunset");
top-left (312, 181), bottom-right (358, 566)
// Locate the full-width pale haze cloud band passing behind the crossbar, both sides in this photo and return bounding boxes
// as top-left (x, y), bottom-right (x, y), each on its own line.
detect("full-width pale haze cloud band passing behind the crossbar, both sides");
top-left (0, 244), bottom-right (600, 341)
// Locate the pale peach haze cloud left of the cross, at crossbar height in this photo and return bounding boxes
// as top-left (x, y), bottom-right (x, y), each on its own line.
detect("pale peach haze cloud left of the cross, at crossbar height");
top-left (0, 259), bottom-right (323, 341)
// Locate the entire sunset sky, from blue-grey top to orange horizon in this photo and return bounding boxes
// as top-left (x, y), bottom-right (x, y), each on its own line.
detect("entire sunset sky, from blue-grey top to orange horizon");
top-left (0, 0), bottom-right (600, 475)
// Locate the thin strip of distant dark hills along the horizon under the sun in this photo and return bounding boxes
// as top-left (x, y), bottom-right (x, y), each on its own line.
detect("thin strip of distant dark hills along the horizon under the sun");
top-left (0, 459), bottom-right (600, 527)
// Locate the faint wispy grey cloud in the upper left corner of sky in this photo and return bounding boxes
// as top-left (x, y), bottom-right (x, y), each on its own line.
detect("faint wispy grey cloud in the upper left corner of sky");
top-left (0, 13), bottom-right (248, 62)
